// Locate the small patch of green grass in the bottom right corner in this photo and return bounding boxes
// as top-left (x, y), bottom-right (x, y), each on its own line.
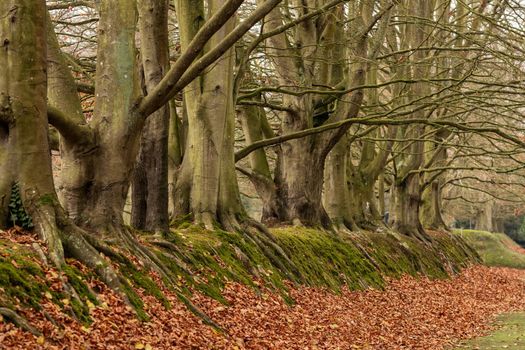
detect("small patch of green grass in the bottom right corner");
top-left (456, 313), bottom-right (525, 350)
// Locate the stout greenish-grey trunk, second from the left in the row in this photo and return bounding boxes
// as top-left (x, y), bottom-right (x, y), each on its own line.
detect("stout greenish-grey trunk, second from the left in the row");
top-left (75, 0), bottom-right (143, 233)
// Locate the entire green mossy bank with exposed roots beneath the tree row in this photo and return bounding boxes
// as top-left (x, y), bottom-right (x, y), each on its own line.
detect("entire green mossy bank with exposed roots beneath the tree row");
top-left (0, 225), bottom-right (479, 330)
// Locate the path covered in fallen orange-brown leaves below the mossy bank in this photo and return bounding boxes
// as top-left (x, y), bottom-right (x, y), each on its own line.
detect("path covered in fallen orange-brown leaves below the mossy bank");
top-left (0, 266), bottom-right (525, 349)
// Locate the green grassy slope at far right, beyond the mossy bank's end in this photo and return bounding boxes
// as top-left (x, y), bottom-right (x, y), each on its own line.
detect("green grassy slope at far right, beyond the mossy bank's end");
top-left (455, 230), bottom-right (525, 269)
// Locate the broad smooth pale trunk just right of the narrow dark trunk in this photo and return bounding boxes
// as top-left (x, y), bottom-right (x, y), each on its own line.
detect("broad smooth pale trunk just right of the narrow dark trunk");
top-left (177, 1), bottom-right (244, 229)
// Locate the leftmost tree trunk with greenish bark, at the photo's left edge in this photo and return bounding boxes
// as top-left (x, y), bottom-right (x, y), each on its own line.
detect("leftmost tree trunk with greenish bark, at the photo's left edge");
top-left (0, 0), bottom-right (64, 266)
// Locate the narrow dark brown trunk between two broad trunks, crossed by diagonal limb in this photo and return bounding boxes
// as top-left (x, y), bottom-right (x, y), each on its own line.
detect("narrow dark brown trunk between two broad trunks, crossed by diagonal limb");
top-left (131, 0), bottom-right (170, 232)
